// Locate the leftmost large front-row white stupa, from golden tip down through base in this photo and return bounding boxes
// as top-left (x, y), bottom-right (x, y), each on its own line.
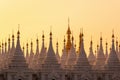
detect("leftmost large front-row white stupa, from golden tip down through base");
top-left (4, 27), bottom-right (32, 80)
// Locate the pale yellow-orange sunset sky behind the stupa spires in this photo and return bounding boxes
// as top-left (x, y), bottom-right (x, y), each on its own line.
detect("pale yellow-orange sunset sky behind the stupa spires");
top-left (0, 0), bottom-right (120, 54)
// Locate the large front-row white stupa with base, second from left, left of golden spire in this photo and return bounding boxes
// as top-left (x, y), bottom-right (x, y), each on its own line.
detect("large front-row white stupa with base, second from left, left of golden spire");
top-left (41, 32), bottom-right (63, 80)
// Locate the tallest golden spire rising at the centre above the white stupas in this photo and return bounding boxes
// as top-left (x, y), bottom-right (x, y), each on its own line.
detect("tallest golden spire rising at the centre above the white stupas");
top-left (66, 18), bottom-right (71, 53)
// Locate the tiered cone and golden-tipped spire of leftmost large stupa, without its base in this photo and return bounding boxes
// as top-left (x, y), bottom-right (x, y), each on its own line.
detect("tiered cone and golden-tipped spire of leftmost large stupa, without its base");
top-left (9, 25), bottom-right (28, 70)
